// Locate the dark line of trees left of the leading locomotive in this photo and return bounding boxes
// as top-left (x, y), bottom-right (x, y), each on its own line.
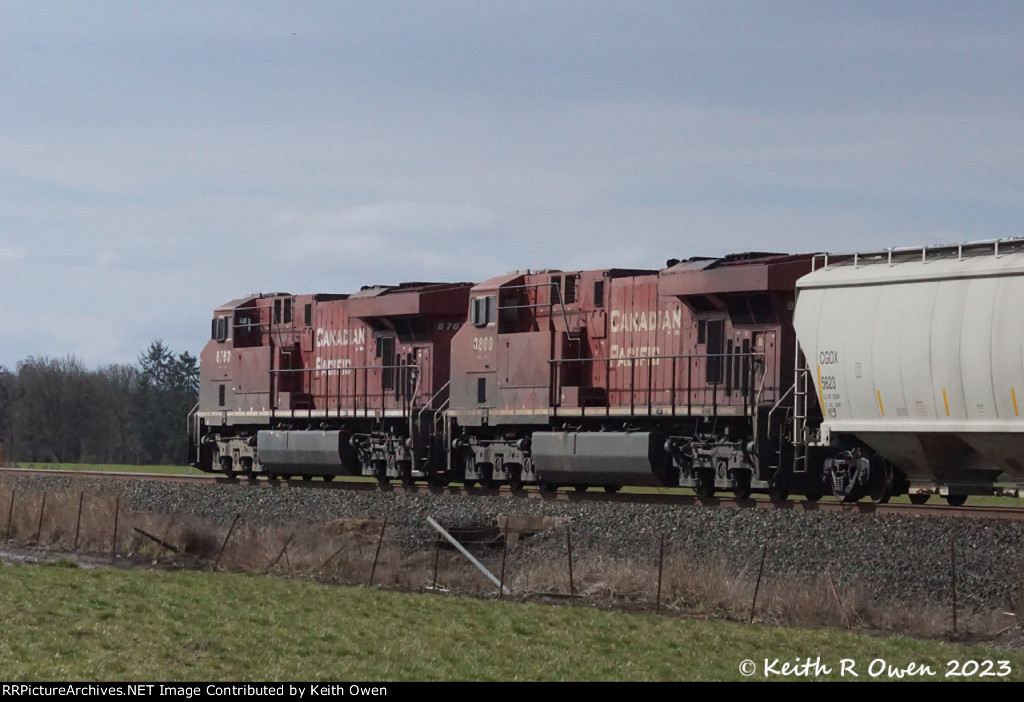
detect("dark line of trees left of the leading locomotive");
top-left (0, 340), bottom-right (199, 465)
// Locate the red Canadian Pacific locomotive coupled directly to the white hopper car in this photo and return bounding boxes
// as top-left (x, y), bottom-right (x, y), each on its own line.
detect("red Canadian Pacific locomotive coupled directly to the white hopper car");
top-left (447, 254), bottom-right (820, 496)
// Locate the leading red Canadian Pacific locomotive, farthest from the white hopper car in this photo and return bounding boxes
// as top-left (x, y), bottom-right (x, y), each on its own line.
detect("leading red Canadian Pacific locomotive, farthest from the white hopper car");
top-left (188, 283), bottom-right (470, 482)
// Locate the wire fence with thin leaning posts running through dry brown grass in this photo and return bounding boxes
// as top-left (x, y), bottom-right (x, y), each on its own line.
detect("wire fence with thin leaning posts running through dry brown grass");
top-left (0, 486), bottom-right (1018, 639)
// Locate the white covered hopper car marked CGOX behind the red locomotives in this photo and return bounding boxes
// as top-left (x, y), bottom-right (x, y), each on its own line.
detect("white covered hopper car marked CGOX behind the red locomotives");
top-left (794, 239), bottom-right (1024, 503)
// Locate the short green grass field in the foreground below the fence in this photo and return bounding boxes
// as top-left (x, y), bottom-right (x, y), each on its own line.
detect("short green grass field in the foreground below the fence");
top-left (0, 567), bottom-right (1024, 681)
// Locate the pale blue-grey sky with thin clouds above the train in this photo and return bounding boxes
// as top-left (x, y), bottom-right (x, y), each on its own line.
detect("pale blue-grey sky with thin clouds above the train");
top-left (0, 0), bottom-right (1024, 369)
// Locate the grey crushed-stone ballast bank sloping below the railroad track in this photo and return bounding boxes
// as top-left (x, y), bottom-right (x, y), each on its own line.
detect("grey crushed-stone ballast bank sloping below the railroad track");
top-left (2, 474), bottom-right (1024, 609)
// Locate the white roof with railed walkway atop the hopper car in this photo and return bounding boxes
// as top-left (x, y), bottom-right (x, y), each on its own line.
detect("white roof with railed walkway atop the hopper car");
top-left (797, 238), bottom-right (1024, 289)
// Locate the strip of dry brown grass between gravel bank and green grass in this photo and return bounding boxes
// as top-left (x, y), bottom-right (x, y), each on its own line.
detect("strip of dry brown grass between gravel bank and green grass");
top-left (0, 481), bottom-right (1024, 637)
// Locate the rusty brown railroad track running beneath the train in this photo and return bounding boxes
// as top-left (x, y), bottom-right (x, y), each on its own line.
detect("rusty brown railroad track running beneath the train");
top-left (0, 468), bottom-right (1024, 520)
